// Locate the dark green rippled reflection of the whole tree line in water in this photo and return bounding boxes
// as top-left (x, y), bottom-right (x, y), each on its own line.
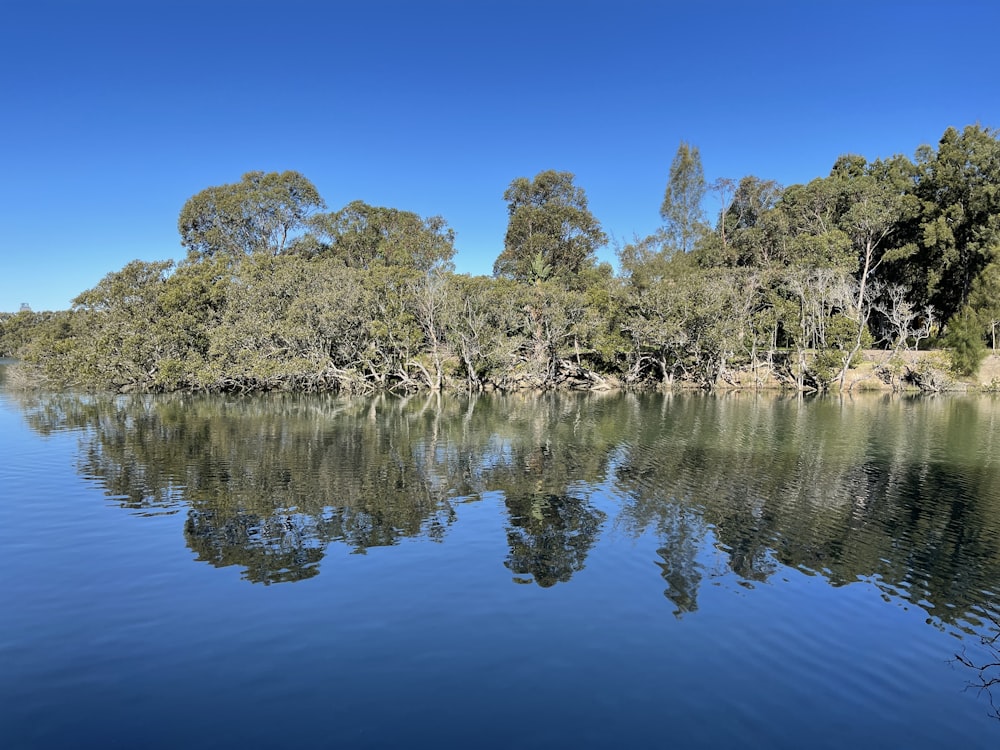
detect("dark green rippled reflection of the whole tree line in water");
top-left (9, 393), bottom-right (1000, 648)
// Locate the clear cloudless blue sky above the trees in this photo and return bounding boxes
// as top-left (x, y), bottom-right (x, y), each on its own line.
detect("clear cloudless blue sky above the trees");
top-left (0, 0), bottom-right (1000, 311)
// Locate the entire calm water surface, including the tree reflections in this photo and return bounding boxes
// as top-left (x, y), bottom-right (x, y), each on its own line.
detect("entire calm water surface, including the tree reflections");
top-left (0, 368), bottom-right (1000, 748)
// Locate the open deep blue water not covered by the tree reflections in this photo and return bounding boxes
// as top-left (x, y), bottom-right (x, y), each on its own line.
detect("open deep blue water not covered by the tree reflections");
top-left (0, 384), bottom-right (1000, 748)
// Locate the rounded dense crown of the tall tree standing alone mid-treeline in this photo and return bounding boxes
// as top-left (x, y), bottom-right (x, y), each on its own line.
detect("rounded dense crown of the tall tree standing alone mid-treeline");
top-left (493, 170), bottom-right (607, 286)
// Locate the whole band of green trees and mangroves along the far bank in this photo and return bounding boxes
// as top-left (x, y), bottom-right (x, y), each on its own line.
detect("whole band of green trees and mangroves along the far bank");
top-left (0, 125), bottom-right (1000, 393)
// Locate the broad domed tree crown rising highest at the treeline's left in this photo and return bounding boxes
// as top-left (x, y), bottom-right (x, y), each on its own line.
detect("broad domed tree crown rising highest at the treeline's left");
top-left (177, 171), bottom-right (325, 259)
